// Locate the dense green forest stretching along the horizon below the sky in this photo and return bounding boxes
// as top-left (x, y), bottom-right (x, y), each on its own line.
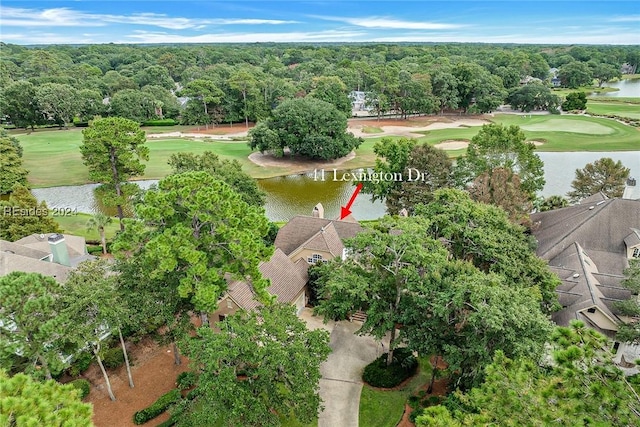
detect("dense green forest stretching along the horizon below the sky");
top-left (0, 44), bottom-right (640, 128)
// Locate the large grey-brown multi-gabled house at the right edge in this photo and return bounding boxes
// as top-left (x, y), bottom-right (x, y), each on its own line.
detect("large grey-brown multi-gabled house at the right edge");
top-left (531, 193), bottom-right (640, 372)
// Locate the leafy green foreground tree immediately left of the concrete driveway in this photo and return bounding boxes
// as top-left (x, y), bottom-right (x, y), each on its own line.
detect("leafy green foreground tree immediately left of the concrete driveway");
top-left (179, 305), bottom-right (331, 427)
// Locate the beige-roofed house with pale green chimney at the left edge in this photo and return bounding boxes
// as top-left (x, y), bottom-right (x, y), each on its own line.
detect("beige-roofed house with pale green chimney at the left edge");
top-left (0, 233), bottom-right (94, 283)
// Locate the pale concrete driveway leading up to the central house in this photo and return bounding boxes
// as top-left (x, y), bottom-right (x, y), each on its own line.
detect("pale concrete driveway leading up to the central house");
top-left (300, 308), bottom-right (388, 427)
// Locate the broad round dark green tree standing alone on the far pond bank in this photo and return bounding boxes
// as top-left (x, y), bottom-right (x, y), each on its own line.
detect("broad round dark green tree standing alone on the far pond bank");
top-left (249, 97), bottom-right (362, 160)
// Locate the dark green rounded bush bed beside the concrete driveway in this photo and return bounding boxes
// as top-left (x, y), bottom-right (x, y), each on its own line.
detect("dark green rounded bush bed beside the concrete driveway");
top-left (362, 348), bottom-right (418, 388)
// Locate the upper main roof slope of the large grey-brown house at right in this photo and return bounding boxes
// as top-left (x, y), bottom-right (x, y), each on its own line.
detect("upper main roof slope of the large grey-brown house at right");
top-left (531, 199), bottom-right (640, 273)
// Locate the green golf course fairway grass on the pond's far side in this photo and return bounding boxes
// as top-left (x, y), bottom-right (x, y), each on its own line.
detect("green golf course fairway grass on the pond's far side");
top-left (16, 113), bottom-right (640, 187)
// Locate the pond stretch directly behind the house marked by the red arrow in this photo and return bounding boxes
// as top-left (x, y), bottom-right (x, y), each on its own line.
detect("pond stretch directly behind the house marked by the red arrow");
top-left (258, 170), bottom-right (386, 221)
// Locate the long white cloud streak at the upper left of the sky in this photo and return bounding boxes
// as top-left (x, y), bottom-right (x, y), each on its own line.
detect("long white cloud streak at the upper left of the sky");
top-left (0, 6), bottom-right (297, 30)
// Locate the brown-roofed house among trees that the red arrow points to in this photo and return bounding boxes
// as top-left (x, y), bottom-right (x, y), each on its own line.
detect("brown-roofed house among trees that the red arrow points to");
top-left (209, 204), bottom-right (363, 322)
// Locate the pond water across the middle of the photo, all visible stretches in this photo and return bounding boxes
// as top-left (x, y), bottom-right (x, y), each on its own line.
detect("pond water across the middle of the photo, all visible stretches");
top-left (32, 151), bottom-right (640, 221)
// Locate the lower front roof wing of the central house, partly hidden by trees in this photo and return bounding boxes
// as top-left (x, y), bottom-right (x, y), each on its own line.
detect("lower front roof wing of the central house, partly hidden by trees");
top-left (228, 249), bottom-right (308, 310)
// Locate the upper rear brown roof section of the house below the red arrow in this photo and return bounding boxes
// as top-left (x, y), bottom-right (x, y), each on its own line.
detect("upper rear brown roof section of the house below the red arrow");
top-left (274, 215), bottom-right (363, 255)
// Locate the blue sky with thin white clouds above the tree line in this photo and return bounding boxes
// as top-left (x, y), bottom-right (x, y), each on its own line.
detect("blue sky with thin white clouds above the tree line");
top-left (0, 0), bottom-right (640, 45)
